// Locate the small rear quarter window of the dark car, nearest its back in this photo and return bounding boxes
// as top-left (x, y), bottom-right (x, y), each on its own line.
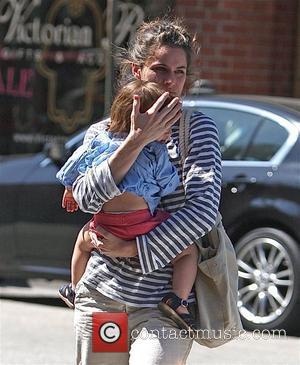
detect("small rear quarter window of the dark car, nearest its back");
top-left (245, 119), bottom-right (289, 161)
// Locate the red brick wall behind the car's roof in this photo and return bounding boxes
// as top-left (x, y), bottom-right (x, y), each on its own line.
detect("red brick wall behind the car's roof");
top-left (175, 0), bottom-right (300, 96)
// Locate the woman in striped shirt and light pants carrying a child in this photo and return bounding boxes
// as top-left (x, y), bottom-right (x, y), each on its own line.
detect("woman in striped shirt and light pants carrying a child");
top-left (73, 19), bottom-right (221, 365)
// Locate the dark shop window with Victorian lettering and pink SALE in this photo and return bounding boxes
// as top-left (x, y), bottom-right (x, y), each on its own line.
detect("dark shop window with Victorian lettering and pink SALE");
top-left (0, 0), bottom-right (144, 154)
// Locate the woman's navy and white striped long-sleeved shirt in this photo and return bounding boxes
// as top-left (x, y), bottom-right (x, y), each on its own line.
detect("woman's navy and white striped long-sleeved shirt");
top-left (73, 112), bottom-right (221, 307)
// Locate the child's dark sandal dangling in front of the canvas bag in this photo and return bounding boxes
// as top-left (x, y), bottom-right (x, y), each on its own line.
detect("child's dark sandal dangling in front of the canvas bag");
top-left (158, 293), bottom-right (197, 332)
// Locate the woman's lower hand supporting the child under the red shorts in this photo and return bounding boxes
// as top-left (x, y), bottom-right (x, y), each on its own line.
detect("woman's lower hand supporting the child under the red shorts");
top-left (90, 226), bottom-right (138, 257)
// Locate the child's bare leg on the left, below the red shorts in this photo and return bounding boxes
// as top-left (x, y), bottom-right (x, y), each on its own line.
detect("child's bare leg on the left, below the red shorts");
top-left (71, 223), bottom-right (94, 290)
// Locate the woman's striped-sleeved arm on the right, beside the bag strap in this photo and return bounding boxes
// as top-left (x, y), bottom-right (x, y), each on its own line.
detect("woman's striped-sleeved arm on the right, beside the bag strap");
top-left (136, 114), bottom-right (221, 273)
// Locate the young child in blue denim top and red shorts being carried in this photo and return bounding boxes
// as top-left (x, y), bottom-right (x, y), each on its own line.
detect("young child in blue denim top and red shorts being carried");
top-left (57, 80), bottom-right (198, 329)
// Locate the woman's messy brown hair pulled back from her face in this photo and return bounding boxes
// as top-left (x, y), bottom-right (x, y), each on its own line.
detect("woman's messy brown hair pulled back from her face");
top-left (117, 18), bottom-right (199, 84)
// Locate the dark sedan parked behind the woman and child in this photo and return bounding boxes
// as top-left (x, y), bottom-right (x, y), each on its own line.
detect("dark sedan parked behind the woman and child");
top-left (0, 96), bottom-right (300, 329)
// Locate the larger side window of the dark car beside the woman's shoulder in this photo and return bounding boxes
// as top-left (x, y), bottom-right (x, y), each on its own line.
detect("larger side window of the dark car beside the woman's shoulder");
top-left (193, 107), bottom-right (261, 160)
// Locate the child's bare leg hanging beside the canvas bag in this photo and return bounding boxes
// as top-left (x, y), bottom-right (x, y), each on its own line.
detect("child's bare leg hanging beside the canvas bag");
top-left (172, 244), bottom-right (198, 313)
